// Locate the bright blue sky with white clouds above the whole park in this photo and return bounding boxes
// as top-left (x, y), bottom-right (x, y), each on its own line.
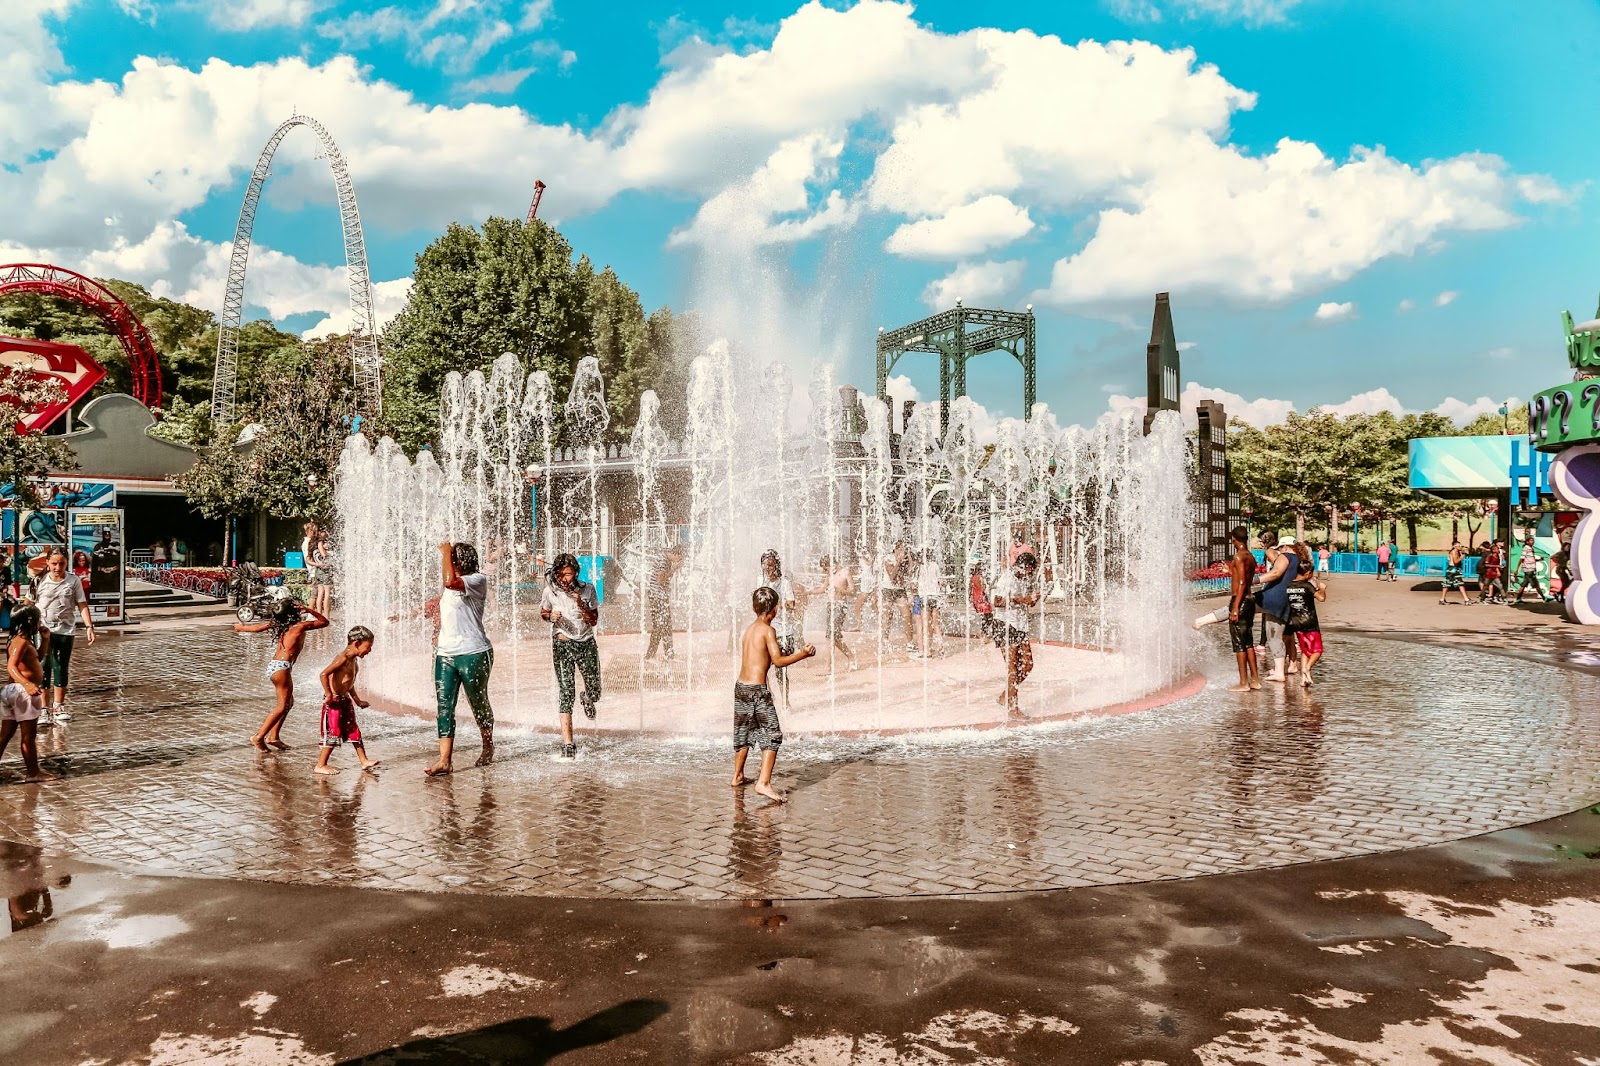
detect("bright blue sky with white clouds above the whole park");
top-left (0, 0), bottom-right (1600, 421)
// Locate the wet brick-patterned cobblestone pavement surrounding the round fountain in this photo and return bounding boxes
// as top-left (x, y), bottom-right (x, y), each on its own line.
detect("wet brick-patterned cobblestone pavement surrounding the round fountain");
top-left (0, 629), bottom-right (1600, 898)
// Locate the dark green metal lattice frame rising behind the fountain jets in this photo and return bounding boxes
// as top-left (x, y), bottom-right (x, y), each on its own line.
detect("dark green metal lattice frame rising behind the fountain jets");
top-left (878, 301), bottom-right (1038, 432)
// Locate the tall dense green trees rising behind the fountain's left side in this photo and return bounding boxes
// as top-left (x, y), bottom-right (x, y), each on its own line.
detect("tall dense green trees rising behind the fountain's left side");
top-left (382, 218), bottom-right (683, 450)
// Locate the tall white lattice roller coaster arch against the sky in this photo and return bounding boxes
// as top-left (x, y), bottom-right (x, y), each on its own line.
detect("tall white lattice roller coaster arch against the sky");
top-left (211, 115), bottom-right (382, 429)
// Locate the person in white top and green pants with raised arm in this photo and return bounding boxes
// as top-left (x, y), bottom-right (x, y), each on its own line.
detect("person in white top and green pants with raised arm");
top-left (422, 541), bottom-right (494, 778)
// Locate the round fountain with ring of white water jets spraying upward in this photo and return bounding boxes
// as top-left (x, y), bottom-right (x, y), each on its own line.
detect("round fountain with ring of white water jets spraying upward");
top-left (338, 344), bottom-right (1189, 733)
